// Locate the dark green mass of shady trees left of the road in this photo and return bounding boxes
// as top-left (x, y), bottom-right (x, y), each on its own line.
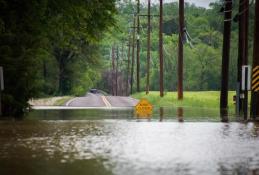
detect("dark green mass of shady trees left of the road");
top-left (0, 0), bottom-right (116, 115)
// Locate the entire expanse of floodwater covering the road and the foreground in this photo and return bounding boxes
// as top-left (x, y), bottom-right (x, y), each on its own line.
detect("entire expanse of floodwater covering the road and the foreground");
top-left (0, 108), bottom-right (259, 175)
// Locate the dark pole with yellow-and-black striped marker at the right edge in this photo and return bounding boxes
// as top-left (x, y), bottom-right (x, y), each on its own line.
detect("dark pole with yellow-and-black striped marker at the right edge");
top-left (251, 0), bottom-right (259, 119)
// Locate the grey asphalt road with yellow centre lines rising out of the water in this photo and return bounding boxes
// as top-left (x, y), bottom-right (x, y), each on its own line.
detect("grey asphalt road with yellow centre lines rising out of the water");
top-left (66, 93), bottom-right (138, 107)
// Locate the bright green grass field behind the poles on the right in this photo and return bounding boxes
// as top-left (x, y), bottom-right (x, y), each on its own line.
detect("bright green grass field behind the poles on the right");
top-left (132, 91), bottom-right (235, 109)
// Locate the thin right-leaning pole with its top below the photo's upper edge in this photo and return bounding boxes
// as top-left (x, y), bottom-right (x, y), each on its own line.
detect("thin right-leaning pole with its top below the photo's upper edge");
top-left (130, 14), bottom-right (136, 94)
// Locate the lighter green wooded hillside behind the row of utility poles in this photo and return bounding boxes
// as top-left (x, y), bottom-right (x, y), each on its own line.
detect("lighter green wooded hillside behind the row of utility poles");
top-left (97, 0), bottom-right (254, 94)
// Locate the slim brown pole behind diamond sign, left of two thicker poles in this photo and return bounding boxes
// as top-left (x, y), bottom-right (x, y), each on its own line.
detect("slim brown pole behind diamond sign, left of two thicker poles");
top-left (146, 0), bottom-right (151, 94)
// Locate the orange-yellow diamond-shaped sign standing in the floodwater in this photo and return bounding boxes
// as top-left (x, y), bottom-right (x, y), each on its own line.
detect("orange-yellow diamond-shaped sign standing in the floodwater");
top-left (135, 99), bottom-right (153, 117)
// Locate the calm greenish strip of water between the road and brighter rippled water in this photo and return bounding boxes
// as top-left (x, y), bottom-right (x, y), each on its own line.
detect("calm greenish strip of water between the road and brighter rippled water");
top-left (26, 107), bottom-right (237, 122)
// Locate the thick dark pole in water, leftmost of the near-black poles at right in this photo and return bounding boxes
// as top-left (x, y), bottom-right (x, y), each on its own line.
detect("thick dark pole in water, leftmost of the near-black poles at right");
top-left (220, 0), bottom-right (232, 120)
